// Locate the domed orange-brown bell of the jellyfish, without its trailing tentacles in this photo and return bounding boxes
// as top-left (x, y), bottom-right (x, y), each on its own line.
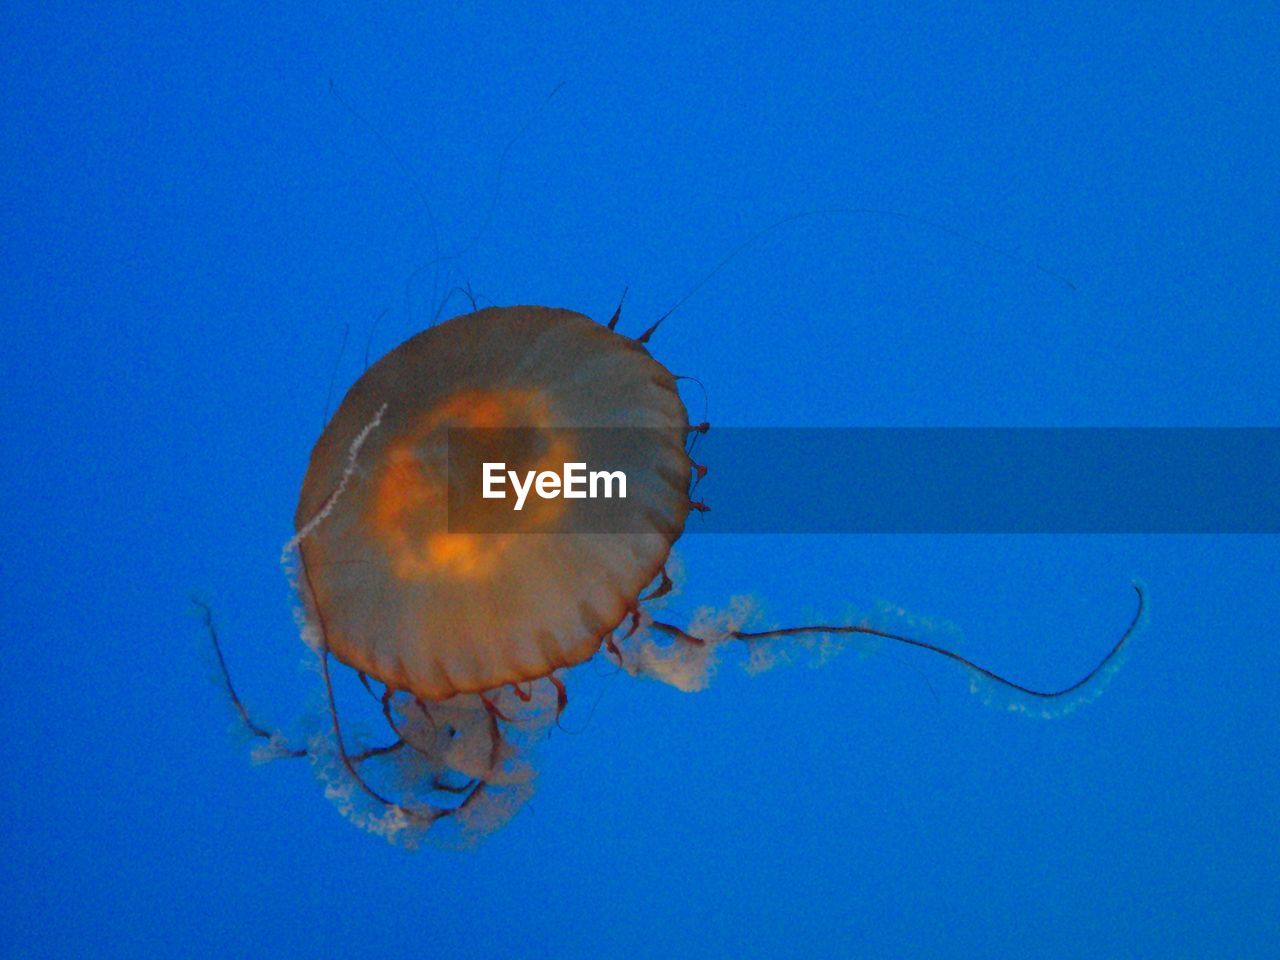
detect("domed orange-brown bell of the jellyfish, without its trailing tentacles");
top-left (294, 306), bottom-right (690, 701)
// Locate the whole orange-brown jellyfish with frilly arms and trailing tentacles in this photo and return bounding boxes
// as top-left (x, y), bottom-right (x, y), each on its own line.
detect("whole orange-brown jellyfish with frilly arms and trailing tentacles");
top-left (204, 305), bottom-right (1143, 846)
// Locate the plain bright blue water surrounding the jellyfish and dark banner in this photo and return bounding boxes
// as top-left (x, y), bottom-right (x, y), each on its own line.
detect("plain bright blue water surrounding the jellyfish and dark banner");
top-left (0, 0), bottom-right (1280, 959)
